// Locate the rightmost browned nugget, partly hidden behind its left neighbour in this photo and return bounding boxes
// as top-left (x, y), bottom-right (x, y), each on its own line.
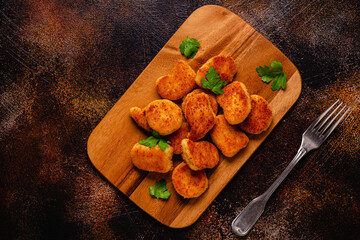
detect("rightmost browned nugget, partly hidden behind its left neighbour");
top-left (239, 95), bottom-right (273, 134)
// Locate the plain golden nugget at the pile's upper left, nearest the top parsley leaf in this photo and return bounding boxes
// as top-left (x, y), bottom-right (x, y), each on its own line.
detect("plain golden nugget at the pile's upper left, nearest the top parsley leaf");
top-left (156, 60), bottom-right (196, 100)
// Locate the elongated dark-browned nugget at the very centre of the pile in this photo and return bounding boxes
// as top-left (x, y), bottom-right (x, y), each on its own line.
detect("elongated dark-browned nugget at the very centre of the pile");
top-left (182, 93), bottom-right (215, 141)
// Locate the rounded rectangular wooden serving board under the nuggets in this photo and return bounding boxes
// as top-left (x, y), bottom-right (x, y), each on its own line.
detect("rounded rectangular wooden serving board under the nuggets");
top-left (87, 5), bottom-right (301, 228)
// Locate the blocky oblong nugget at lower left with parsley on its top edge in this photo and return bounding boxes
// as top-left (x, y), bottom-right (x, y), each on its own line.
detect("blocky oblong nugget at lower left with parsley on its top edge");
top-left (130, 143), bottom-right (173, 173)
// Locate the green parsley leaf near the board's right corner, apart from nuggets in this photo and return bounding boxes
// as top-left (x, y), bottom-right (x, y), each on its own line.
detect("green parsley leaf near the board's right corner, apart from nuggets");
top-left (256, 61), bottom-right (287, 91)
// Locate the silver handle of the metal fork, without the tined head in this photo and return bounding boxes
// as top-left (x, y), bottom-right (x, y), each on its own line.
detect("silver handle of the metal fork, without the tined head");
top-left (231, 147), bottom-right (308, 236)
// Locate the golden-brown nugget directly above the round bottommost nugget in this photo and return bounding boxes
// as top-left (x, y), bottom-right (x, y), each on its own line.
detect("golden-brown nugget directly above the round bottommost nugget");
top-left (181, 139), bottom-right (219, 171)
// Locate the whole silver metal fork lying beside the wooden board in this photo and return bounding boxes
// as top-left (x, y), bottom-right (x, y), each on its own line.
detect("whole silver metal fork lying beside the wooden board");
top-left (231, 100), bottom-right (350, 236)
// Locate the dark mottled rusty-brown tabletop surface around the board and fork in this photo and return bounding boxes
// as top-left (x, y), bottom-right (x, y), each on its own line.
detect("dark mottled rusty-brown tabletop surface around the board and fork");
top-left (0, 0), bottom-right (360, 239)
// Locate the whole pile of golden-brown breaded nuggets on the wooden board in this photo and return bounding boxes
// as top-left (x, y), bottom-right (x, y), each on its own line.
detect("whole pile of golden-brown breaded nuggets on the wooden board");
top-left (130, 56), bottom-right (272, 198)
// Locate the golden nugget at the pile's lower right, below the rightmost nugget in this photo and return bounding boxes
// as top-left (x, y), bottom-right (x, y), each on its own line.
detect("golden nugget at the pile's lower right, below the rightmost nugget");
top-left (210, 115), bottom-right (249, 157)
